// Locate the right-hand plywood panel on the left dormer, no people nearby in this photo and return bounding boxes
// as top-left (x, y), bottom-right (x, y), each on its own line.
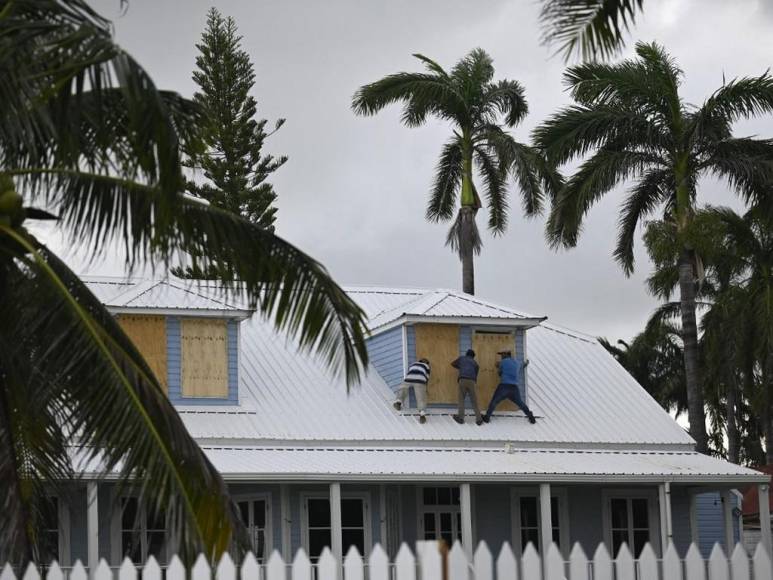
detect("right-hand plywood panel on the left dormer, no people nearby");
top-left (180, 318), bottom-right (228, 398)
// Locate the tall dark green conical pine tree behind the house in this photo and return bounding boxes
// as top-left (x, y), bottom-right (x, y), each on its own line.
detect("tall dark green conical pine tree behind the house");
top-left (188, 8), bottom-right (287, 231)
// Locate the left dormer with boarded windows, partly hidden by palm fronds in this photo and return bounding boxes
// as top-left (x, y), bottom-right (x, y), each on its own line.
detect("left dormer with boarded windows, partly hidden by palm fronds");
top-left (89, 280), bottom-right (252, 406)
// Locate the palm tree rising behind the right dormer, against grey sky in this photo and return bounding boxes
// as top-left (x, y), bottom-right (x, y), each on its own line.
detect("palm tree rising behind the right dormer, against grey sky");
top-left (352, 48), bottom-right (559, 294)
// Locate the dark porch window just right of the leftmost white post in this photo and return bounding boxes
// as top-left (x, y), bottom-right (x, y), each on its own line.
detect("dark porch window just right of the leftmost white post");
top-left (114, 497), bottom-right (167, 564)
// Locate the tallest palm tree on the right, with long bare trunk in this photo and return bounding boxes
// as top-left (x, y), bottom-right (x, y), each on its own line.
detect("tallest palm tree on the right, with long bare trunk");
top-left (534, 43), bottom-right (773, 451)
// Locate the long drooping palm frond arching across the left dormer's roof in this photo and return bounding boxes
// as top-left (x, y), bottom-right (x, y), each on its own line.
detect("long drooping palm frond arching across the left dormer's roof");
top-left (9, 170), bottom-right (367, 384)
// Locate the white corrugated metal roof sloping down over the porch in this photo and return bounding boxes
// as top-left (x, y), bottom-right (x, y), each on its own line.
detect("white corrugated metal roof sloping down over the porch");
top-left (78, 281), bottom-right (753, 481)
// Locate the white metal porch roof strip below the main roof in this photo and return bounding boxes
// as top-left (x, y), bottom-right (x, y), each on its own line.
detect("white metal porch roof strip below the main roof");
top-left (169, 446), bottom-right (770, 485)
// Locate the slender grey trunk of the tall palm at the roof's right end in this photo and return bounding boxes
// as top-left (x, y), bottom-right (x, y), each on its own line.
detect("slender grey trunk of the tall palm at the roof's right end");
top-left (679, 249), bottom-right (708, 453)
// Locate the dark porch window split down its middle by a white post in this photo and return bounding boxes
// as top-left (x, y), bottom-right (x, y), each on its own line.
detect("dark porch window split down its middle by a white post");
top-left (303, 495), bottom-right (370, 562)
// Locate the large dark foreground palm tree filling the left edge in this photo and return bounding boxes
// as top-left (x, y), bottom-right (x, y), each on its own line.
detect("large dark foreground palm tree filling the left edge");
top-left (0, 0), bottom-right (366, 562)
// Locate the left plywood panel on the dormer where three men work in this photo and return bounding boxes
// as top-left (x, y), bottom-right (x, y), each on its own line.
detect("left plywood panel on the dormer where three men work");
top-left (415, 324), bottom-right (459, 403)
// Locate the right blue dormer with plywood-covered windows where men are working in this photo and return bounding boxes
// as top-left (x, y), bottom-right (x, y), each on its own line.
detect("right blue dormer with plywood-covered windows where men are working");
top-left (360, 290), bottom-right (545, 411)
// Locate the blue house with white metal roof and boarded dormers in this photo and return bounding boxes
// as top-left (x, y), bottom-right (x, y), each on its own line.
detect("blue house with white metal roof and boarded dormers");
top-left (46, 278), bottom-right (769, 566)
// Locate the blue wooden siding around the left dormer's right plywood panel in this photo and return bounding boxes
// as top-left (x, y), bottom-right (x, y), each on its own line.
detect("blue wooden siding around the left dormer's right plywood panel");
top-left (166, 316), bottom-right (239, 405)
